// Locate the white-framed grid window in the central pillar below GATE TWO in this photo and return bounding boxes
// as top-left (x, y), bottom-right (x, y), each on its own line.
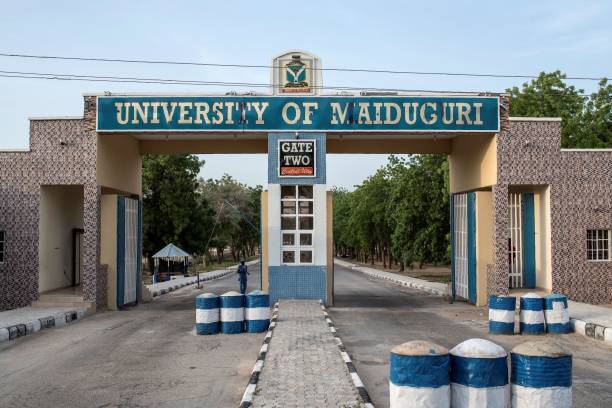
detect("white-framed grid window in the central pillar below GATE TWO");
top-left (281, 186), bottom-right (314, 265)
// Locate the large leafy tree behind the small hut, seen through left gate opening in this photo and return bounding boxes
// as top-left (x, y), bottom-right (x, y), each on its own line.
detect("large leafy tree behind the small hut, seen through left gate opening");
top-left (142, 155), bottom-right (213, 264)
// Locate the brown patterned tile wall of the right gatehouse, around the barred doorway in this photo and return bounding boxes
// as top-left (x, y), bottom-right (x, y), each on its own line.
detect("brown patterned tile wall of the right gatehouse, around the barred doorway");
top-left (489, 120), bottom-right (612, 303)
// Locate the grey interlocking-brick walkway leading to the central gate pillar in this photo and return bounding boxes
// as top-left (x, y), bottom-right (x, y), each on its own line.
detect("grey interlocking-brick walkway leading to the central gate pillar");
top-left (253, 300), bottom-right (363, 408)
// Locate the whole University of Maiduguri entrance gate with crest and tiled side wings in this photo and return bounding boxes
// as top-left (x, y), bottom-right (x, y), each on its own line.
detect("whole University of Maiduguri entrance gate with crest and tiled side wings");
top-left (0, 52), bottom-right (612, 308)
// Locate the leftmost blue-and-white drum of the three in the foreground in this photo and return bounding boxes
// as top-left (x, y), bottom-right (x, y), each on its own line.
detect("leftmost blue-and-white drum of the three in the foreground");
top-left (389, 340), bottom-right (450, 408)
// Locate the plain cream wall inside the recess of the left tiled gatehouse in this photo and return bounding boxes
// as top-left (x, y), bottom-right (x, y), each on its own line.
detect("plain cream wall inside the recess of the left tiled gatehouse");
top-left (38, 186), bottom-right (83, 292)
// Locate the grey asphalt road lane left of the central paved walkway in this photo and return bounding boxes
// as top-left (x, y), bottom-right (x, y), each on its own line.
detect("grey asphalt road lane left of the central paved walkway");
top-left (0, 265), bottom-right (264, 407)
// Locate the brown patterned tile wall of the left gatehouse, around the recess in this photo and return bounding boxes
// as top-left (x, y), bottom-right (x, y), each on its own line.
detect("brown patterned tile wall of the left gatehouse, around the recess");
top-left (0, 119), bottom-right (106, 310)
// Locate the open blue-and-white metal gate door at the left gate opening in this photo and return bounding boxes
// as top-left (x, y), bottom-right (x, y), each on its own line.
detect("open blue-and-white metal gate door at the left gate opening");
top-left (117, 197), bottom-right (140, 306)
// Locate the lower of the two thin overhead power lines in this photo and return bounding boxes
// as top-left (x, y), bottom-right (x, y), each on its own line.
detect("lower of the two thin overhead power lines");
top-left (0, 70), bottom-right (589, 98)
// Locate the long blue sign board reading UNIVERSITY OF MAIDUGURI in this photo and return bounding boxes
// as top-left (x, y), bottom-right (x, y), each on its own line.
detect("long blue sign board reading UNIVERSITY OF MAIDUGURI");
top-left (97, 96), bottom-right (499, 133)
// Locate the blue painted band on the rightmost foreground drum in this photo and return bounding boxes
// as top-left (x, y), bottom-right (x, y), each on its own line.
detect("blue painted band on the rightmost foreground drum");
top-left (510, 353), bottom-right (572, 388)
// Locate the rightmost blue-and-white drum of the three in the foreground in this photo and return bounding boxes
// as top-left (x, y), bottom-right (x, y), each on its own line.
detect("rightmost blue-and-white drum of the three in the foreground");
top-left (510, 341), bottom-right (572, 408)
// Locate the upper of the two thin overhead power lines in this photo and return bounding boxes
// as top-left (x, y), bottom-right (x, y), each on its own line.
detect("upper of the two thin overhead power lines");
top-left (0, 53), bottom-right (609, 81)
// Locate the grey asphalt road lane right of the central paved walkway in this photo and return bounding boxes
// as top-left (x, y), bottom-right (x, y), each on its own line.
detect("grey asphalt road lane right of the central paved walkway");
top-left (330, 265), bottom-right (612, 408)
